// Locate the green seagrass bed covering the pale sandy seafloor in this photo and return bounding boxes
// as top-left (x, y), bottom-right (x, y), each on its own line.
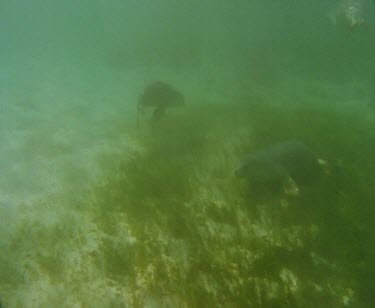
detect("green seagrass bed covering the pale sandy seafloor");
top-left (0, 101), bottom-right (375, 307)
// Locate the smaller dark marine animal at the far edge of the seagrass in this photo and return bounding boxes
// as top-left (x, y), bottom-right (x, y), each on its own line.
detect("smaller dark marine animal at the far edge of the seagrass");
top-left (137, 81), bottom-right (185, 125)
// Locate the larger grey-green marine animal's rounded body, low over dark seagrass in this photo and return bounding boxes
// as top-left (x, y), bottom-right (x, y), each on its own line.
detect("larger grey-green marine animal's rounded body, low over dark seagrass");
top-left (236, 141), bottom-right (321, 194)
